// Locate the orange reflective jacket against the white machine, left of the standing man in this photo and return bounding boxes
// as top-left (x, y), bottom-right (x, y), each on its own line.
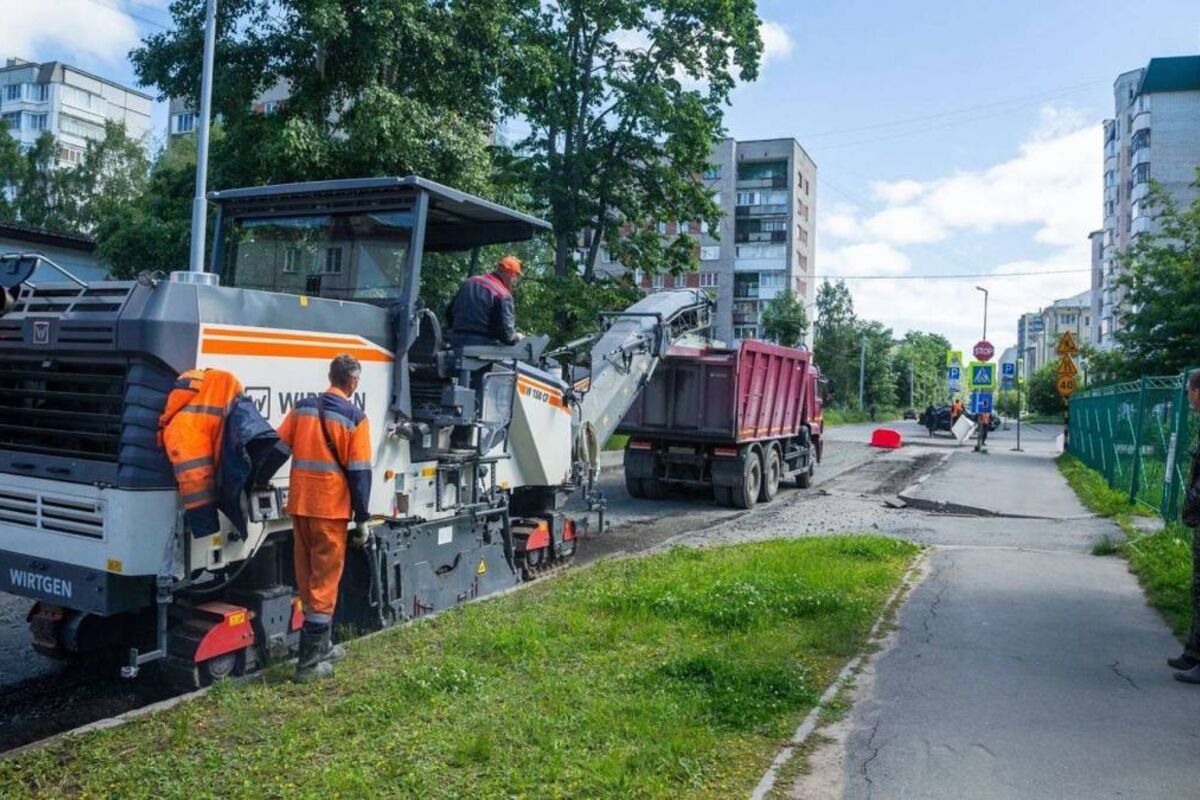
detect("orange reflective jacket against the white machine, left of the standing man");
top-left (158, 369), bottom-right (242, 536)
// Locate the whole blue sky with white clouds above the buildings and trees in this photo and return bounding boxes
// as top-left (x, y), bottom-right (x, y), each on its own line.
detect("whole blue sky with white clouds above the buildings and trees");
top-left (0, 0), bottom-right (1200, 357)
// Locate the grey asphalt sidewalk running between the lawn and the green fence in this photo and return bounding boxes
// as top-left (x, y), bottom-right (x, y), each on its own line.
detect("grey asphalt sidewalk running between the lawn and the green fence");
top-left (816, 424), bottom-right (1200, 800)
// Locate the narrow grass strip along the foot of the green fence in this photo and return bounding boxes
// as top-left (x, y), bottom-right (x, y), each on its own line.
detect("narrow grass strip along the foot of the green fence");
top-left (1058, 453), bottom-right (1193, 639)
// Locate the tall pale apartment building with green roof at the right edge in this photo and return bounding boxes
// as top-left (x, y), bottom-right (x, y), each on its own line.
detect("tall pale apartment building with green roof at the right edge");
top-left (1093, 55), bottom-right (1200, 348)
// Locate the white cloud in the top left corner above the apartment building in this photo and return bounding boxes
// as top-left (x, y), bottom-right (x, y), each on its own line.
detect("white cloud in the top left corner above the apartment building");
top-left (0, 0), bottom-right (138, 62)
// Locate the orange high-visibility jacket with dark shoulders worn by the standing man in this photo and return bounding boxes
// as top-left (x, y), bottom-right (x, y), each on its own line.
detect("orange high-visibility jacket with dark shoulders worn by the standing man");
top-left (280, 386), bottom-right (372, 522)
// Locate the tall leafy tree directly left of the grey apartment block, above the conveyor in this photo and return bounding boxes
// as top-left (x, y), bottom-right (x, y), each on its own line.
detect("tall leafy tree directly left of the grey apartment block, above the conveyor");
top-left (500, 0), bottom-right (762, 281)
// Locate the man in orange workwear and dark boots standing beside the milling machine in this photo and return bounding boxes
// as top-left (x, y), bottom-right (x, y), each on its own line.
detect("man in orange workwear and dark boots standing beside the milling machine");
top-left (280, 355), bottom-right (372, 681)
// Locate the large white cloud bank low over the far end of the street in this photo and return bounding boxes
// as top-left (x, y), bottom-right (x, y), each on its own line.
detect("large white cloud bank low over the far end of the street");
top-left (816, 107), bottom-right (1102, 349)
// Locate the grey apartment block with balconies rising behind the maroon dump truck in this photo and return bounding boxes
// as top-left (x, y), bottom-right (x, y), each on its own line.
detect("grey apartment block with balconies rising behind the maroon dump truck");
top-left (596, 138), bottom-right (817, 342)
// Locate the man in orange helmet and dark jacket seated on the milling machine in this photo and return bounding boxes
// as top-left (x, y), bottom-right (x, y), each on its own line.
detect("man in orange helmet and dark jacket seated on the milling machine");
top-left (446, 255), bottom-right (524, 345)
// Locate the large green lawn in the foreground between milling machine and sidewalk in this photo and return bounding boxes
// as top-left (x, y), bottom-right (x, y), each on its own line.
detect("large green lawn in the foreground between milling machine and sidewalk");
top-left (0, 536), bottom-right (918, 799)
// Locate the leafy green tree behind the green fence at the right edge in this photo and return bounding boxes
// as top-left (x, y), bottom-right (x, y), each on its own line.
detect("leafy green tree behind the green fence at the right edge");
top-left (1102, 168), bottom-right (1200, 377)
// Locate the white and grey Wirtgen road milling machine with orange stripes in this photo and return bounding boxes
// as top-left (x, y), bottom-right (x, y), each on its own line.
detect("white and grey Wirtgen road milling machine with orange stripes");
top-left (0, 176), bottom-right (710, 686)
